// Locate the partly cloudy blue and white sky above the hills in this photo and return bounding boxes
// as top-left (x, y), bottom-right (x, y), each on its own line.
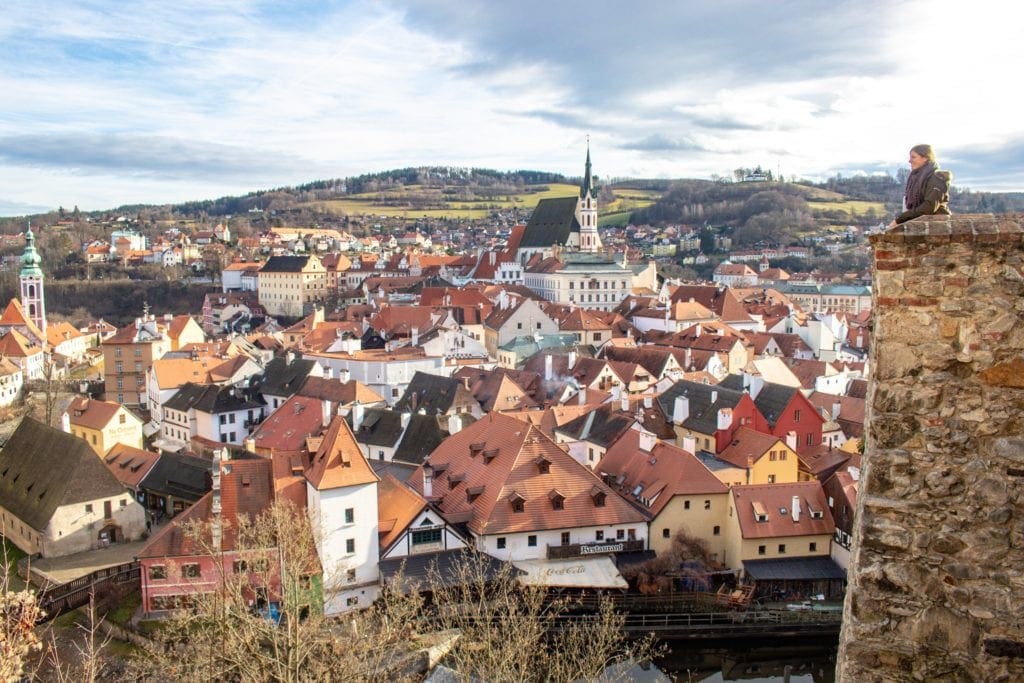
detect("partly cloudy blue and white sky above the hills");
top-left (0, 0), bottom-right (1024, 215)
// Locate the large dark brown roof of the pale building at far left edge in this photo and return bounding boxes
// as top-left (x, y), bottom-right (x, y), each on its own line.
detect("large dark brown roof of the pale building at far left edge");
top-left (0, 418), bottom-right (125, 531)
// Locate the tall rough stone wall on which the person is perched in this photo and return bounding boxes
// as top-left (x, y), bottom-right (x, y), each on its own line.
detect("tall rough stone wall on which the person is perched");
top-left (837, 214), bottom-right (1024, 682)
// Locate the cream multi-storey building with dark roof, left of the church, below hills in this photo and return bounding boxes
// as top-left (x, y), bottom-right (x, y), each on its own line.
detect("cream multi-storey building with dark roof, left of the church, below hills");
top-left (258, 254), bottom-right (330, 317)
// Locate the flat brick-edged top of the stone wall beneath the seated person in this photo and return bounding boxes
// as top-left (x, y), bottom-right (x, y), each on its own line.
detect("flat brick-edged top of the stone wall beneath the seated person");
top-left (870, 213), bottom-right (1024, 245)
